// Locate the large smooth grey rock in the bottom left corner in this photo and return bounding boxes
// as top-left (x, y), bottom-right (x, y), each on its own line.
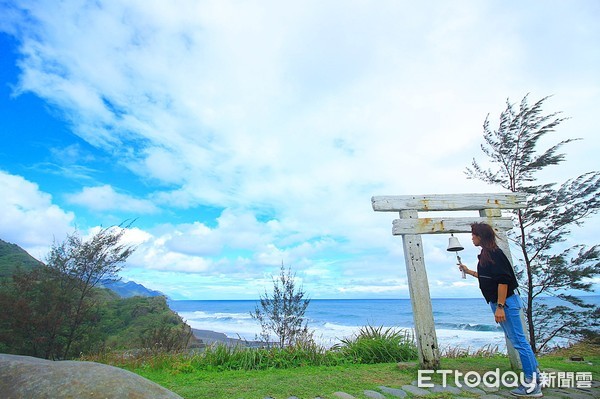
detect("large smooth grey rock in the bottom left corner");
top-left (0, 354), bottom-right (182, 399)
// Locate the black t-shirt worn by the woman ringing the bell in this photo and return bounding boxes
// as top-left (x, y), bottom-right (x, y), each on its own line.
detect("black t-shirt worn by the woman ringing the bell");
top-left (477, 248), bottom-right (519, 303)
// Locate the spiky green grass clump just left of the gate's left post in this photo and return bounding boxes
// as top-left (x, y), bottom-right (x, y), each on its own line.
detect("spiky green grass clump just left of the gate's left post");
top-left (334, 326), bottom-right (418, 364)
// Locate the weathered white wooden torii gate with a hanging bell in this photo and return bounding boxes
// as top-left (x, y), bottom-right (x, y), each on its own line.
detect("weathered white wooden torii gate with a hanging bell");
top-left (371, 193), bottom-right (527, 370)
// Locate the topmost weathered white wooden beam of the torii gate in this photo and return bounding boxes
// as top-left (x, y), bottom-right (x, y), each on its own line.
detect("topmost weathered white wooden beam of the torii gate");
top-left (371, 193), bottom-right (527, 212)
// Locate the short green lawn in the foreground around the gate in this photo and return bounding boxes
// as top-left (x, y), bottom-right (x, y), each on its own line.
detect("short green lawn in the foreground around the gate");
top-left (82, 329), bottom-right (600, 399)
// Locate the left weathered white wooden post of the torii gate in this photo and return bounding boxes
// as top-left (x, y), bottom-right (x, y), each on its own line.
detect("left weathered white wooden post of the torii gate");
top-left (400, 211), bottom-right (440, 370)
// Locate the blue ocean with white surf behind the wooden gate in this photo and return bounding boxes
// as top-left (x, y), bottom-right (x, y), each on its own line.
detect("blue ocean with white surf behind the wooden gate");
top-left (169, 296), bottom-right (600, 351)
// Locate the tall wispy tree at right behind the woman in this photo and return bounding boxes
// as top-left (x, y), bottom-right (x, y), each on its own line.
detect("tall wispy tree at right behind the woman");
top-left (466, 96), bottom-right (600, 352)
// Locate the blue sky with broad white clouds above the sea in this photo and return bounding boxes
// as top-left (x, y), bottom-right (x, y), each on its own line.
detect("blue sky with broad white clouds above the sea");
top-left (0, 0), bottom-right (600, 299)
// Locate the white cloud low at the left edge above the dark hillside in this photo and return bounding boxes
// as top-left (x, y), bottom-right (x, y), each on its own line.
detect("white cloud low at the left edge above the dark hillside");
top-left (0, 170), bottom-right (75, 260)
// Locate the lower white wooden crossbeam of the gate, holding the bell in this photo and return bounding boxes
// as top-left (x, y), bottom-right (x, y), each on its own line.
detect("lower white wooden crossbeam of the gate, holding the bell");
top-left (392, 217), bottom-right (514, 236)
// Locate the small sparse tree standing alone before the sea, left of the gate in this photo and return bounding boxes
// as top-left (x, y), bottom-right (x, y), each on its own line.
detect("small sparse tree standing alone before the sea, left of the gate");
top-left (250, 262), bottom-right (310, 348)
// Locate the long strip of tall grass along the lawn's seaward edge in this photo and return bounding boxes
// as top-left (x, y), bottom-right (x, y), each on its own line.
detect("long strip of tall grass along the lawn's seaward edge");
top-left (81, 326), bottom-right (417, 374)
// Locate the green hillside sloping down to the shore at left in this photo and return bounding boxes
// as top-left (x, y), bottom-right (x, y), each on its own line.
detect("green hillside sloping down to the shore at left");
top-left (0, 240), bottom-right (200, 359)
